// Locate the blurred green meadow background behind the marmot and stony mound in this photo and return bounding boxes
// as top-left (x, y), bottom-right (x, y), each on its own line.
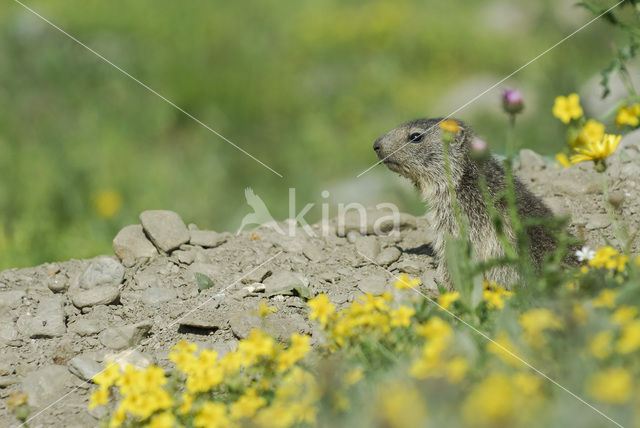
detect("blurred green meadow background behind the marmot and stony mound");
top-left (0, 0), bottom-right (632, 269)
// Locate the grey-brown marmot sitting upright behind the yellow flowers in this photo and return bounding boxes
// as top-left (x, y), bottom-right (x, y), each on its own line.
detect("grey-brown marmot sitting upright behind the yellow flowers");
top-left (373, 118), bottom-right (572, 289)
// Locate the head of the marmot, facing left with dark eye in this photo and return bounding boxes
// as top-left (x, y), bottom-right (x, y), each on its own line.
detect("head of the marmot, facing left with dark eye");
top-left (373, 119), bottom-right (472, 187)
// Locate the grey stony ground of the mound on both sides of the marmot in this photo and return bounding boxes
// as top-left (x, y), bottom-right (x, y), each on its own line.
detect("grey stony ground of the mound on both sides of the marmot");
top-left (0, 134), bottom-right (640, 427)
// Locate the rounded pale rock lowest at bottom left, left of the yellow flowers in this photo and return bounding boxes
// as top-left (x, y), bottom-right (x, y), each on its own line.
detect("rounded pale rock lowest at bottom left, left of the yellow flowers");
top-left (21, 365), bottom-right (74, 409)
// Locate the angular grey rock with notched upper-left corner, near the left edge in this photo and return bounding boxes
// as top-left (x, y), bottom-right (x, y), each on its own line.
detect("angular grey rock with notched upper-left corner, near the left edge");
top-left (16, 296), bottom-right (67, 338)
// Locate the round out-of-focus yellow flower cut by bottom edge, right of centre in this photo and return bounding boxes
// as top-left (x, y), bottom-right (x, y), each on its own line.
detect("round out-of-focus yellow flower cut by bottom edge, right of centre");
top-left (375, 382), bottom-right (427, 428)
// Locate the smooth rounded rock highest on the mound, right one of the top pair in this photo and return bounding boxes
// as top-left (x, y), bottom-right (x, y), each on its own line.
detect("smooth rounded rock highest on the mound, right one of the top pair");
top-left (140, 210), bottom-right (191, 253)
